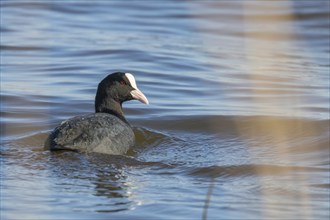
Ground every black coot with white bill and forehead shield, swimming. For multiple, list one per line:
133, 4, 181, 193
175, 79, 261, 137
45, 72, 149, 155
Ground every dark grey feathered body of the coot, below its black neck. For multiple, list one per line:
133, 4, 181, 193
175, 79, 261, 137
45, 113, 135, 154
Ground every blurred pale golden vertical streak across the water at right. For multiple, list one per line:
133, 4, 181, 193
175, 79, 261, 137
237, 1, 313, 219
